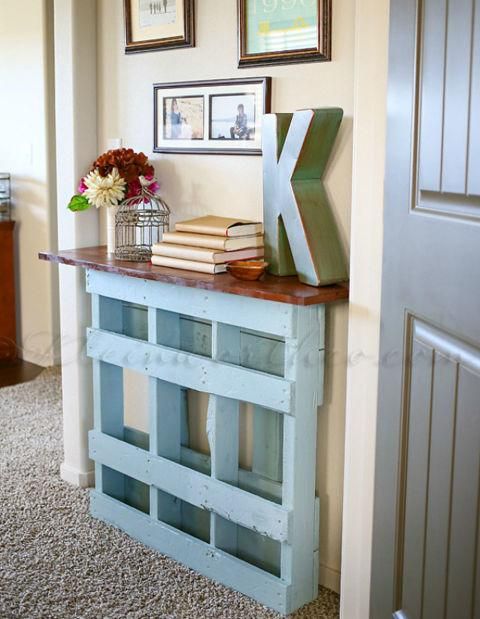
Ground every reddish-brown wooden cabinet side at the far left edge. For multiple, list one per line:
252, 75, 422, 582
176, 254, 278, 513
0, 221, 17, 360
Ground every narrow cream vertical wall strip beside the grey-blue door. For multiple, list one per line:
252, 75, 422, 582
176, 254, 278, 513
341, 0, 390, 619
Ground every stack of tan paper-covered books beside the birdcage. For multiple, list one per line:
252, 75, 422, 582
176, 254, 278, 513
152, 215, 263, 273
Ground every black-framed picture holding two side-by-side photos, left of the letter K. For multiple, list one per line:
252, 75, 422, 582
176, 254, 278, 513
153, 77, 271, 155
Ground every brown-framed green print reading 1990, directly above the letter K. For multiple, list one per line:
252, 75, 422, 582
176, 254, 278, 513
237, 0, 332, 67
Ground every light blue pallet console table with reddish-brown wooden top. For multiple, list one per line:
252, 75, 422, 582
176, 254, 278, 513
40, 248, 348, 614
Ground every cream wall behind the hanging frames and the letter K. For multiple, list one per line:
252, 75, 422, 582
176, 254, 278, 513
97, 0, 354, 590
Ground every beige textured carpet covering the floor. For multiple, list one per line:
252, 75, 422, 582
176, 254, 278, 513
0, 370, 338, 619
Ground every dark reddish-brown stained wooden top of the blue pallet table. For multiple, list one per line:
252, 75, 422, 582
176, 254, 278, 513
39, 246, 348, 305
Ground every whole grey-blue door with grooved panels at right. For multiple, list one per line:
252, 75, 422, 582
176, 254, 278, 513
370, 0, 480, 619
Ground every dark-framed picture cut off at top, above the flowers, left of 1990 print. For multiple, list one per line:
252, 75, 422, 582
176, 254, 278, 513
124, 0, 195, 54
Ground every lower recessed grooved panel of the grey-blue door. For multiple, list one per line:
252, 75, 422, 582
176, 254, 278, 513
397, 317, 480, 619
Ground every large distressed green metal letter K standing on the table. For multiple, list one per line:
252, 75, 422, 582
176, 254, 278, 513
262, 108, 348, 286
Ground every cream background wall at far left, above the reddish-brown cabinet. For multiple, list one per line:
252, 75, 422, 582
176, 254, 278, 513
0, 0, 58, 366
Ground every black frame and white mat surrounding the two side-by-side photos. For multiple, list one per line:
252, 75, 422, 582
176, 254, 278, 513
153, 77, 272, 155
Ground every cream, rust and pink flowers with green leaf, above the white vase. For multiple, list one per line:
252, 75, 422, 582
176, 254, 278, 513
68, 148, 159, 211
